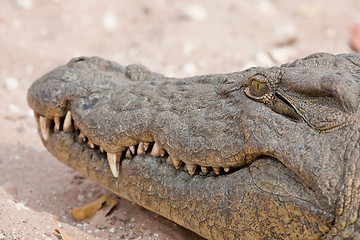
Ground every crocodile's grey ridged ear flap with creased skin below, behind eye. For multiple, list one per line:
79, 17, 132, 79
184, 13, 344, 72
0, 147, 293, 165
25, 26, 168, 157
277, 71, 360, 130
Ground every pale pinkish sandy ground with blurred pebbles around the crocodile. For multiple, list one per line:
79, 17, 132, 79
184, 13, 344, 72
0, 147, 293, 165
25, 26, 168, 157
0, 0, 360, 240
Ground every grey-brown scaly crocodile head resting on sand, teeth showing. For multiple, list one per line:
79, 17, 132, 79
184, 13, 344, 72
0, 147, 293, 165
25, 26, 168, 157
27, 53, 360, 239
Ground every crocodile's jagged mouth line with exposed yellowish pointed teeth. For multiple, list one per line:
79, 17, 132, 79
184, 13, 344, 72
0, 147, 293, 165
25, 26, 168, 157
34, 111, 242, 178
